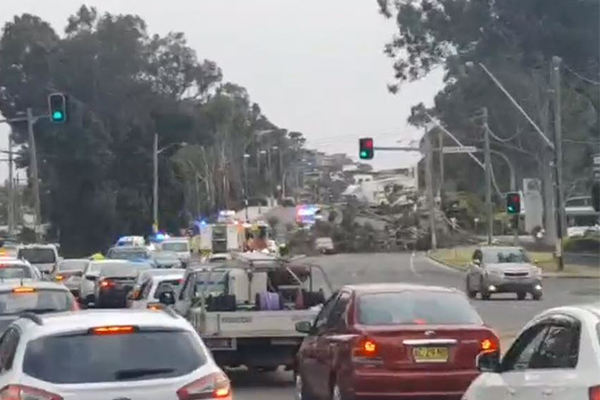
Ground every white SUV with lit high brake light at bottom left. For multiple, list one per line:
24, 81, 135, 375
0, 310, 231, 400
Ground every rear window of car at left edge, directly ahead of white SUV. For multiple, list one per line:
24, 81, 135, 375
0, 288, 74, 315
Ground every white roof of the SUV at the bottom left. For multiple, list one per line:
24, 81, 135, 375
16, 309, 193, 339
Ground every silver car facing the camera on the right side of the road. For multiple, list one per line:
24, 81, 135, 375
466, 246, 543, 300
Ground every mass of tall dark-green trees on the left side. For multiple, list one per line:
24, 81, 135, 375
0, 6, 302, 254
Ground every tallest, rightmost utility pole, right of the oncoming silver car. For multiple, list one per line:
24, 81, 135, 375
551, 56, 566, 271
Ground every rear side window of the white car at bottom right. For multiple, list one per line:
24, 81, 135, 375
529, 324, 580, 369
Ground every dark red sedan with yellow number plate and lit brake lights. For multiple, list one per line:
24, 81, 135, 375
295, 284, 500, 400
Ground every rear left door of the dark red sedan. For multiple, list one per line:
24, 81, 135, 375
315, 291, 351, 399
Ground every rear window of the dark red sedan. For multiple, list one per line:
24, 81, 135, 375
358, 291, 482, 325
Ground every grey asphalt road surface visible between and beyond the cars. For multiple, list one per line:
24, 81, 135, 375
231, 253, 600, 400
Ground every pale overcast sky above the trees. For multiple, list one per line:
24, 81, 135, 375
0, 0, 442, 180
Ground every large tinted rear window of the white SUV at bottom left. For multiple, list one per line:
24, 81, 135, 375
23, 331, 207, 382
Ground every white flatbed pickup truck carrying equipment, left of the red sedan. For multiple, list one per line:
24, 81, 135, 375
159, 253, 332, 371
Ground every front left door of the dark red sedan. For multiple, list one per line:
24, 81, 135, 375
297, 293, 338, 396
